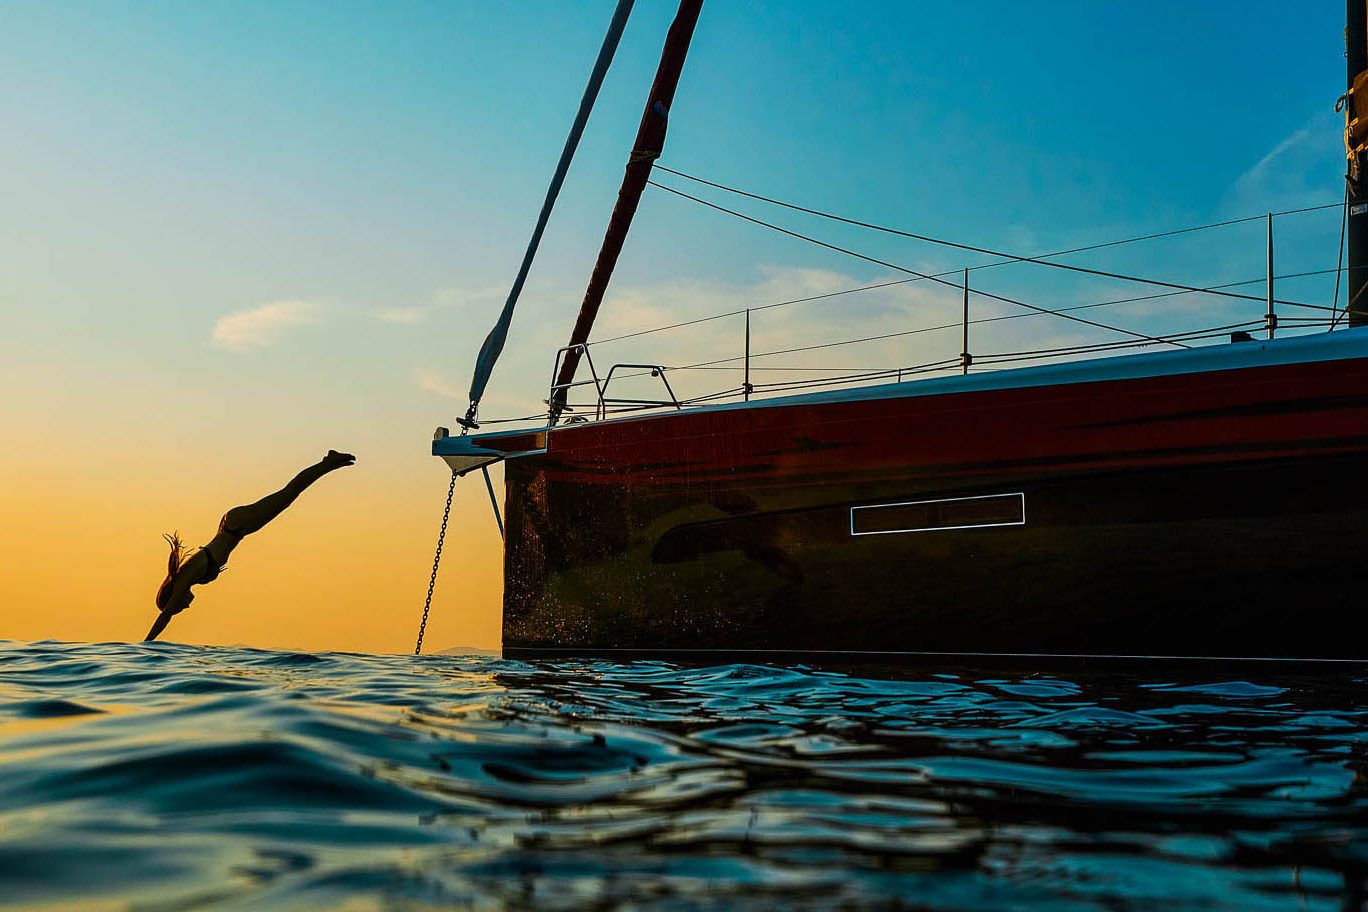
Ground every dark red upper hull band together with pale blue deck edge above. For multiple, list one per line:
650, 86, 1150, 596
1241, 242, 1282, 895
454, 331, 1368, 485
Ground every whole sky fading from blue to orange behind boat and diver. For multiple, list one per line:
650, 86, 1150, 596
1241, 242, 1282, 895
0, 0, 1345, 652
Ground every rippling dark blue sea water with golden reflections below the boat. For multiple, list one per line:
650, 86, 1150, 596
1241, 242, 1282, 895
0, 643, 1368, 912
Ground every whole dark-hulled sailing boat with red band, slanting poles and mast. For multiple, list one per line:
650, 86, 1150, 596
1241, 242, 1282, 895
432, 0, 1368, 659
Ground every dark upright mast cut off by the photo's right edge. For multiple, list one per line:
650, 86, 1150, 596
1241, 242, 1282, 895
1345, 0, 1368, 327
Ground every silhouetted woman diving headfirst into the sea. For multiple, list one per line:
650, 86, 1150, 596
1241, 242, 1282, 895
146, 450, 356, 640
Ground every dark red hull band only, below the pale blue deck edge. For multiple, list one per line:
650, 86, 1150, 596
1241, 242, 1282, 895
547, 352, 1368, 484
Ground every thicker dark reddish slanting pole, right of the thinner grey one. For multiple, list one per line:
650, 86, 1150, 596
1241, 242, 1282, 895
550, 0, 703, 424
